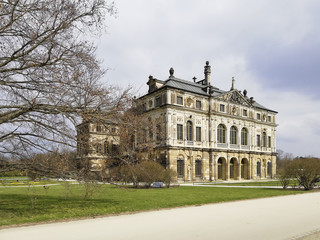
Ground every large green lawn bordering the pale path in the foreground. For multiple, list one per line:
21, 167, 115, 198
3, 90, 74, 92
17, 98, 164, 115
0, 184, 303, 226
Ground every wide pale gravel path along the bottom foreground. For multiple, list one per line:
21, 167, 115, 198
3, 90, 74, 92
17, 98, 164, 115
0, 192, 320, 240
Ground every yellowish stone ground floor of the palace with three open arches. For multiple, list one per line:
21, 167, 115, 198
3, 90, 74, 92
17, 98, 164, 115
144, 149, 276, 181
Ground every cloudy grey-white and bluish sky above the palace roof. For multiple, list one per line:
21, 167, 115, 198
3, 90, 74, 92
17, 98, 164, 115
98, 0, 320, 157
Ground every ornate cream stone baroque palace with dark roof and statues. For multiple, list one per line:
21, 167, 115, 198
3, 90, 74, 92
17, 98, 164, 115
78, 61, 277, 181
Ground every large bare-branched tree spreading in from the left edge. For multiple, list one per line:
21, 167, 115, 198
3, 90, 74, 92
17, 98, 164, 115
0, 0, 123, 163
